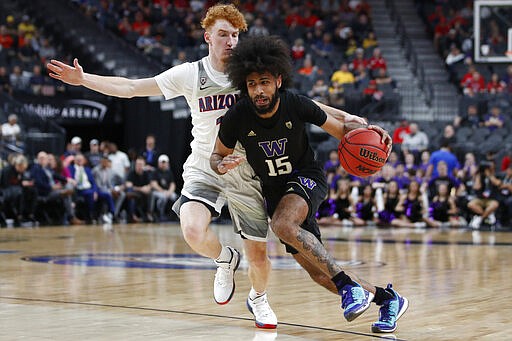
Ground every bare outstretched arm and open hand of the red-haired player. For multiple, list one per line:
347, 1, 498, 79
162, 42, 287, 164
46, 58, 162, 98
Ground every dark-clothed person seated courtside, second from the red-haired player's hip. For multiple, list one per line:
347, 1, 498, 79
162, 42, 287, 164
125, 156, 153, 222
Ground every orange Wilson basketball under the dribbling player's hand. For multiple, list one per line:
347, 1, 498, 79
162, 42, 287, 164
338, 128, 388, 178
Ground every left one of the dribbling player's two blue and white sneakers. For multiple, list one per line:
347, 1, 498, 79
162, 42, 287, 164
341, 282, 373, 322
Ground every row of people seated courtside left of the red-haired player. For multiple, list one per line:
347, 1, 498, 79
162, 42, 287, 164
0, 135, 177, 226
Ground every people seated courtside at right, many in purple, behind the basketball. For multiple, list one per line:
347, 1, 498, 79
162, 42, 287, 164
317, 115, 512, 229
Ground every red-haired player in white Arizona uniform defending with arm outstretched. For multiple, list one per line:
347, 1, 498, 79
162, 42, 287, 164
47, 4, 380, 329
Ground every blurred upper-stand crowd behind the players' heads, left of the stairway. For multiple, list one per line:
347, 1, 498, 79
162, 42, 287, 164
76, 0, 399, 119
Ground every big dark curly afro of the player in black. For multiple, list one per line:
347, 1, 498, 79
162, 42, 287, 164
226, 36, 293, 95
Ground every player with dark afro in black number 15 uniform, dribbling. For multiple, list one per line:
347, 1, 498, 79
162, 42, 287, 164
210, 37, 408, 332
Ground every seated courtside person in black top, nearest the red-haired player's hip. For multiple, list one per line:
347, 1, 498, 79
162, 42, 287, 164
150, 154, 177, 221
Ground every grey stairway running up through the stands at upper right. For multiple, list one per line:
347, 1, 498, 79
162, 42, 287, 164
368, 0, 458, 121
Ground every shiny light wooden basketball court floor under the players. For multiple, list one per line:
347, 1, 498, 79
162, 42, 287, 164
0, 223, 512, 341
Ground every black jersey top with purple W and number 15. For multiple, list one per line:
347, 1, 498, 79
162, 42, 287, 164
219, 91, 327, 196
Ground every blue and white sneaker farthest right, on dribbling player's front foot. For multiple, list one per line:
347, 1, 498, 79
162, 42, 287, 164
372, 284, 409, 333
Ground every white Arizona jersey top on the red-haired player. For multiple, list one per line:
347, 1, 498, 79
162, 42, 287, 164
155, 57, 238, 159
